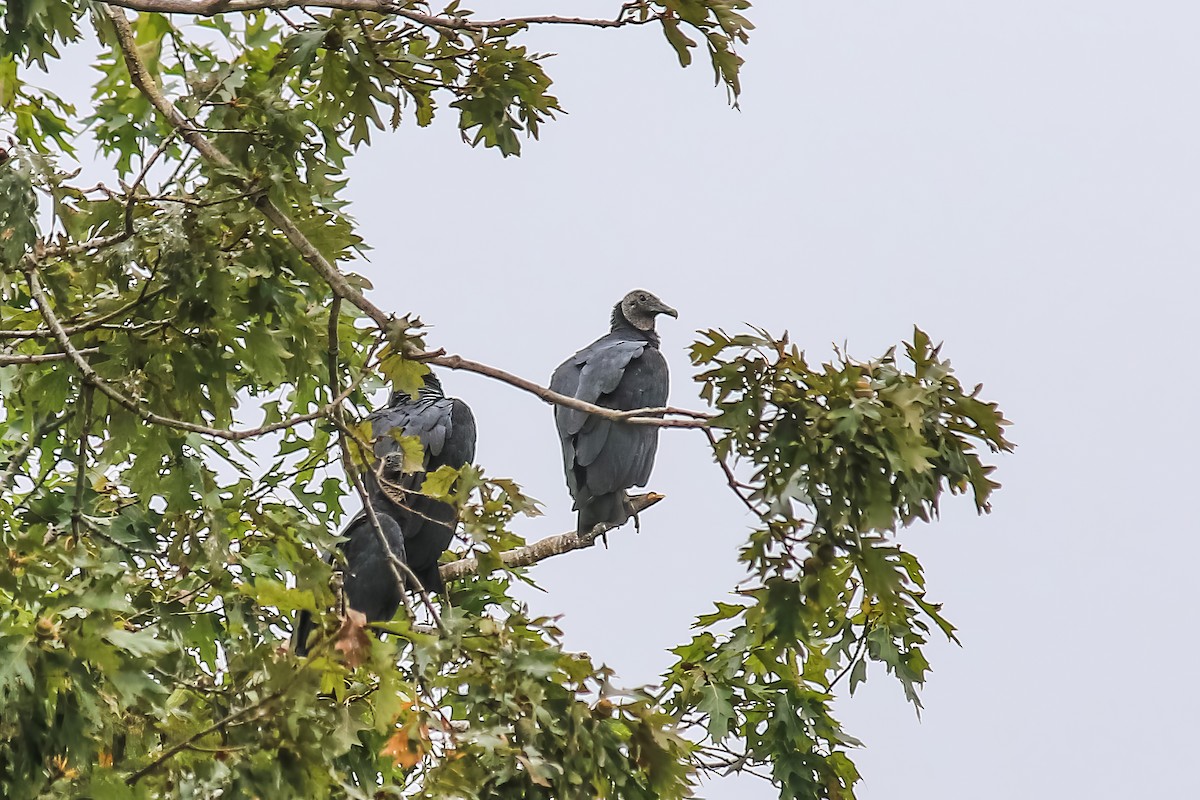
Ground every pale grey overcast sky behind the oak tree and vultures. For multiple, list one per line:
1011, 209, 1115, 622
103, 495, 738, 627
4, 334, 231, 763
340, 0, 1200, 800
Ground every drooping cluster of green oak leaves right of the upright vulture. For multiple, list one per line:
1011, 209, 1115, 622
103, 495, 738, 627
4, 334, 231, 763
665, 330, 1012, 799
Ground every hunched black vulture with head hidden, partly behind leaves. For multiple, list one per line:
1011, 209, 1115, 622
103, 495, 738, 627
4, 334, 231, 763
293, 372, 475, 655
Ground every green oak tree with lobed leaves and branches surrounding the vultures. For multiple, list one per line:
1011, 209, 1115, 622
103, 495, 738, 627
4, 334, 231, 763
0, 0, 1012, 800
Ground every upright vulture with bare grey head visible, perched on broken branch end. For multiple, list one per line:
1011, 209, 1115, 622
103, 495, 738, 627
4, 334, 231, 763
550, 289, 679, 533
